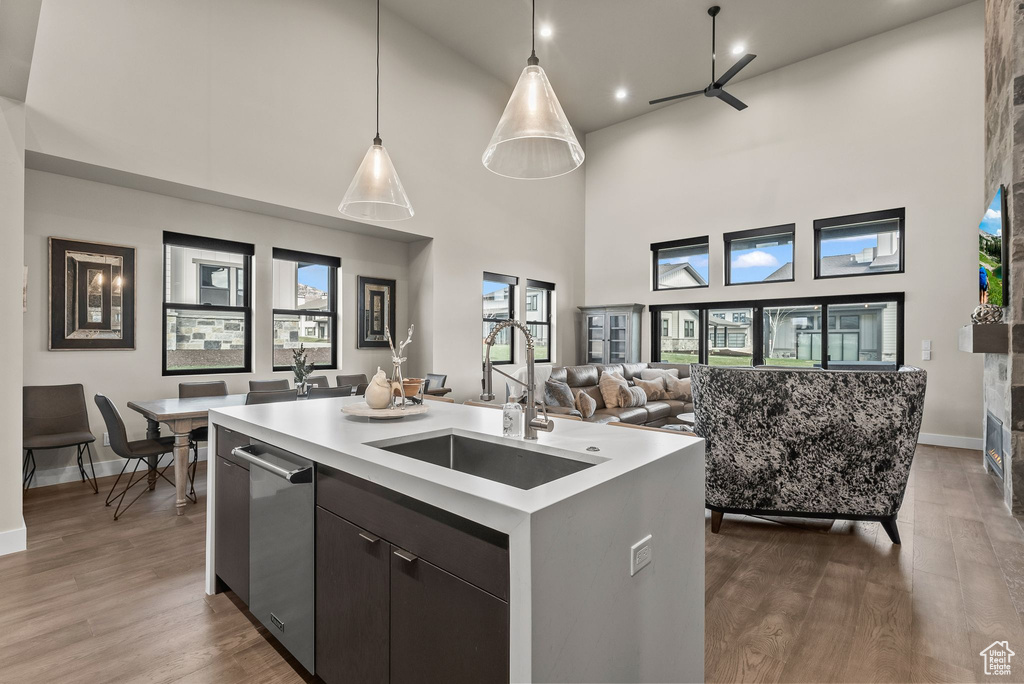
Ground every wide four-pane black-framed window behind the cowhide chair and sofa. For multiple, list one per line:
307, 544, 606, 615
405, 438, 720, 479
651, 293, 904, 370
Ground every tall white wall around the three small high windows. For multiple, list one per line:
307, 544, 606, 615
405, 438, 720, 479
586, 2, 986, 438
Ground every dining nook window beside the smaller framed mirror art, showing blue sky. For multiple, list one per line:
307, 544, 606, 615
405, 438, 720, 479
273, 247, 341, 371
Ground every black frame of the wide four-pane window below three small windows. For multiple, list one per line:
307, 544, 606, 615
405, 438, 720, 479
650, 292, 906, 370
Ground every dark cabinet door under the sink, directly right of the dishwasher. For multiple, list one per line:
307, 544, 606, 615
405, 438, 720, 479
316, 508, 391, 684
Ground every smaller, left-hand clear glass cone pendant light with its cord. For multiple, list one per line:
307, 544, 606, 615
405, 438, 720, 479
338, 0, 415, 221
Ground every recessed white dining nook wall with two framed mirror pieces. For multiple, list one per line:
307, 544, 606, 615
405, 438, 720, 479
24, 171, 410, 471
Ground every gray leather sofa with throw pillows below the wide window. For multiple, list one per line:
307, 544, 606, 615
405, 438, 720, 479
538, 364, 693, 427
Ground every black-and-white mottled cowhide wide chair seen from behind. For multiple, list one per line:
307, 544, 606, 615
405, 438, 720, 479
690, 365, 927, 544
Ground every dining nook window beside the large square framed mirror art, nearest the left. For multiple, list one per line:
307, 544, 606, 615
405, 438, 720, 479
163, 231, 254, 375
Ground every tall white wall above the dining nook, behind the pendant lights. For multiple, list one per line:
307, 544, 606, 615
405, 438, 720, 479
27, 0, 584, 398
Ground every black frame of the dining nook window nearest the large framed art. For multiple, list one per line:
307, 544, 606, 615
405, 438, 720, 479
161, 230, 256, 376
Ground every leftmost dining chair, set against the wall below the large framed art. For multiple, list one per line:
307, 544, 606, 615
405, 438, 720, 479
22, 385, 99, 493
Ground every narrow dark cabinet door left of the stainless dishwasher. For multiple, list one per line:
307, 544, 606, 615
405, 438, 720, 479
214, 456, 249, 605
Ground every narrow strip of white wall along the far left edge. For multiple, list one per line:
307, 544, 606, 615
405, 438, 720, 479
0, 97, 26, 555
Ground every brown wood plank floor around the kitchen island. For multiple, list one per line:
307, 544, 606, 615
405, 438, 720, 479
8, 446, 1024, 684
